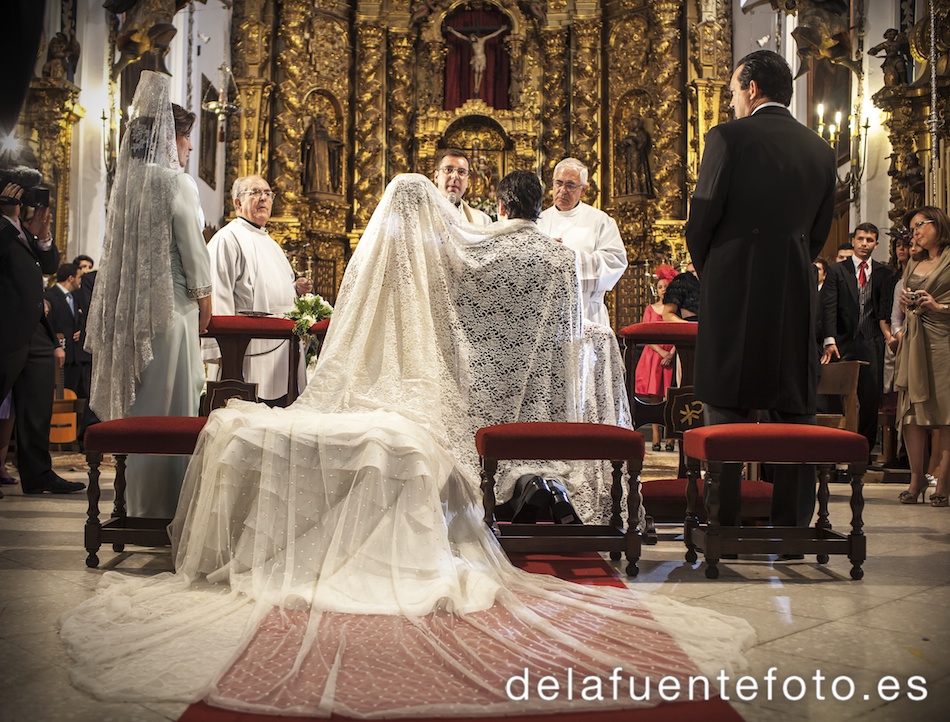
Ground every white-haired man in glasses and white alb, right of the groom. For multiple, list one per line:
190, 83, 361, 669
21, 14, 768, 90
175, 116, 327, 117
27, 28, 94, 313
538, 158, 627, 326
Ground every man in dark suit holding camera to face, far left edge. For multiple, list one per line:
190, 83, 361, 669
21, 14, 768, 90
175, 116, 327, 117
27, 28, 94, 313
0, 167, 86, 494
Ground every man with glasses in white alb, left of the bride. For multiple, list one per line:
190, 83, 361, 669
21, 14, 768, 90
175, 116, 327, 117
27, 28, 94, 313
203, 175, 313, 405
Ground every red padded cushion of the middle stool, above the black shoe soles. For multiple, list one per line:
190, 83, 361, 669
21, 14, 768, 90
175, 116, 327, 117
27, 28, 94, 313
475, 421, 643, 461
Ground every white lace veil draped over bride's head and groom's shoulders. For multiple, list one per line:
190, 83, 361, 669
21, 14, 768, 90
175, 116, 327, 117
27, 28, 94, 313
295, 175, 583, 480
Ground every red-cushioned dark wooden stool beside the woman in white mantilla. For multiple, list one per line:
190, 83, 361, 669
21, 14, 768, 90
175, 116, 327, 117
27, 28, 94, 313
83, 416, 208, 567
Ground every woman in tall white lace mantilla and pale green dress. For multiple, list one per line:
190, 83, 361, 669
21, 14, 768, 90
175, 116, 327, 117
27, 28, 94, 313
86, 71, 211, 518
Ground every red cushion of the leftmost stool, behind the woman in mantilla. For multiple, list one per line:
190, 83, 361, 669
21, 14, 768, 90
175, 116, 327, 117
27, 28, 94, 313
83, 416, 208, 455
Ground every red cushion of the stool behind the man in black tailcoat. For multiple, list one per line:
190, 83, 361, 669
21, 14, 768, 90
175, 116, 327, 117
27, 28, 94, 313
683, 424, 868, 464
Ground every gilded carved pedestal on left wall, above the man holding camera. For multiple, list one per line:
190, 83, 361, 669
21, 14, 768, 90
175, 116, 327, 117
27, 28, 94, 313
20, 78, 86, 253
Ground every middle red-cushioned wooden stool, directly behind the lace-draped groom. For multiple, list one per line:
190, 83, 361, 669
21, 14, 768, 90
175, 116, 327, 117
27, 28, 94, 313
475, 422, 643, 576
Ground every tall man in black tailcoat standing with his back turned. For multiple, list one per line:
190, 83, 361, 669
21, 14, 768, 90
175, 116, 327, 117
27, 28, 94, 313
686, 50, 836, 526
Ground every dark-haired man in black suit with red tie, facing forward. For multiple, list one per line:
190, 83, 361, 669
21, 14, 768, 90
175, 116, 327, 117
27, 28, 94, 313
821, 223, 894, 449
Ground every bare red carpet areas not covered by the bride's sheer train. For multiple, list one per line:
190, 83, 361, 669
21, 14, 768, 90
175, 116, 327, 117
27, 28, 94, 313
179, 552, 742, 722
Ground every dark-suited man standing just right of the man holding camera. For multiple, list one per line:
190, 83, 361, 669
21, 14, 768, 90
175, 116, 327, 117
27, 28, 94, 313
44, 263, 91, 399
